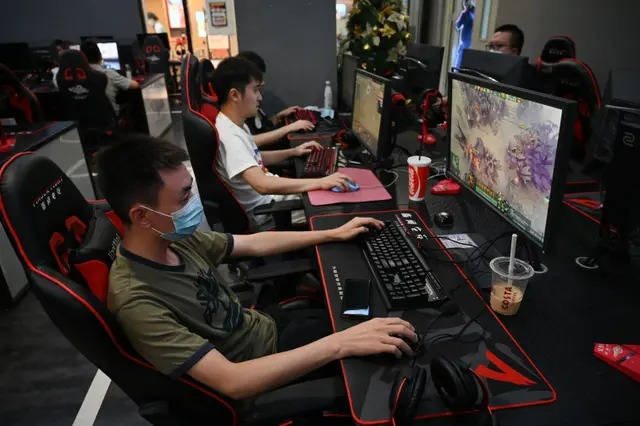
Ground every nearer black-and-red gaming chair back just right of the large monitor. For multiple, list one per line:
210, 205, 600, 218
551, 58, 601, 159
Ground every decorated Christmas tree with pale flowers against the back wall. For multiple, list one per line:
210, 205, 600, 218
341, 0, 411, 76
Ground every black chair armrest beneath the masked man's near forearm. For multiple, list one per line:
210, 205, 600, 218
243, 377, 349, 422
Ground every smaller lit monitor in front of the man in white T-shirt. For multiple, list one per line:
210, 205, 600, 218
352, 69, 392, 159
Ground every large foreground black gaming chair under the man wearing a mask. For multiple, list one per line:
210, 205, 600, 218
0, 153, 346, 426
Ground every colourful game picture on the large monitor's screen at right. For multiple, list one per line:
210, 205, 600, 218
449, 79, 562, 243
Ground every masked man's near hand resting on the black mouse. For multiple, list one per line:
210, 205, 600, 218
325, 318, 418, 359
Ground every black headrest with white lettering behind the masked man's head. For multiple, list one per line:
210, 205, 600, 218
0, 153, 93, 269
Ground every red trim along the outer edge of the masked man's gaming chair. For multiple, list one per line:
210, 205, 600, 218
0, 152, 238, 426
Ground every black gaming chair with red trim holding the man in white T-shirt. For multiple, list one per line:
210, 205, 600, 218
181, 54, 302, 234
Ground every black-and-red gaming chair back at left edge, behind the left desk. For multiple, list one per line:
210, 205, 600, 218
0, 64, 42, 125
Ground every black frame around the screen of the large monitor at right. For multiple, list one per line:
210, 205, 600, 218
447, 72, 577, 252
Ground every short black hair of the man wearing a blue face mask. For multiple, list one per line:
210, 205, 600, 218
97, 134, 189, 225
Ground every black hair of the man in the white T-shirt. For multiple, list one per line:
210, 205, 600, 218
211, 57, 262, 105
